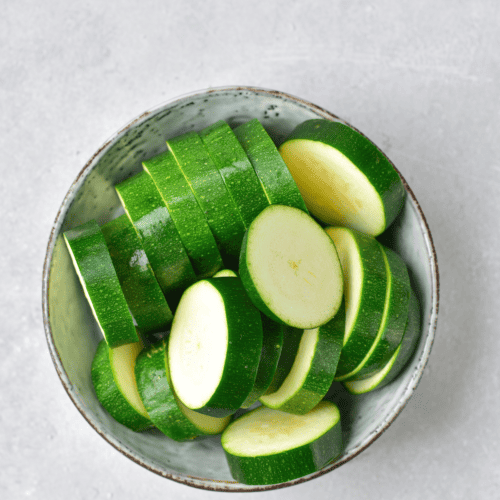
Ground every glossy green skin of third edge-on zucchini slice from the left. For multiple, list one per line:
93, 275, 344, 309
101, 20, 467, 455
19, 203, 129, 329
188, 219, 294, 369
115, 171, 196, 307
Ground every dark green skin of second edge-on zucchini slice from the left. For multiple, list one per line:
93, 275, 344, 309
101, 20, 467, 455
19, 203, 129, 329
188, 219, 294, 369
101, 215, 173, 335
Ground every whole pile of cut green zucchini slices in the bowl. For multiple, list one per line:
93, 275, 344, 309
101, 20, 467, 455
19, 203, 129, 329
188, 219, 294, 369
64, 119, 420, 484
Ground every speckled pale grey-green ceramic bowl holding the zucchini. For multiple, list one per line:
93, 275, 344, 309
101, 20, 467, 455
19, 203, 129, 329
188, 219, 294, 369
43, 87, 439, 492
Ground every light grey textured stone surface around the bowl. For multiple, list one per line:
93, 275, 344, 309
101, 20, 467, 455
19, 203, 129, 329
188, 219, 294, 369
0, 0, 500, 500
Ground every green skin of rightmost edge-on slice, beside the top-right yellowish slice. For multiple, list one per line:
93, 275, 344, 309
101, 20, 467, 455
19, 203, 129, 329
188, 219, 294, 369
234, 118, 309, 214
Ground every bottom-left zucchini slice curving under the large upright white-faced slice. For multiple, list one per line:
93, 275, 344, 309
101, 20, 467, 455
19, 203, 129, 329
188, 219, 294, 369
135, 340, 231, 441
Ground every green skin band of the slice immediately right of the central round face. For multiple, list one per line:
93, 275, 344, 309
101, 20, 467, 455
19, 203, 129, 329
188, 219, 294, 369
326, 228, 387, 380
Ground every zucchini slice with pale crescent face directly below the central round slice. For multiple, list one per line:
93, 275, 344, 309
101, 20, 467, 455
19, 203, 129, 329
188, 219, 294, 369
260, 303, 345, 415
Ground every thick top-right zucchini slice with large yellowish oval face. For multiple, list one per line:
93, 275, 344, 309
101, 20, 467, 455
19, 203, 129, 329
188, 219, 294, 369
279, 119, 405, 236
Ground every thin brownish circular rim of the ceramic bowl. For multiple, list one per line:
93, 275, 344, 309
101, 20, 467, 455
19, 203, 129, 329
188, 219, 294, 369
42, 85, 439, 493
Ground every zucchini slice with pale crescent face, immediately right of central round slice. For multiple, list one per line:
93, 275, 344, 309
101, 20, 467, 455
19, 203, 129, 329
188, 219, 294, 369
325, 227, 387, 380
